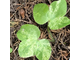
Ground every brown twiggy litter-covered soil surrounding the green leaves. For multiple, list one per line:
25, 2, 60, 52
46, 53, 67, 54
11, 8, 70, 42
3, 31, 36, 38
10, 0, 70, 60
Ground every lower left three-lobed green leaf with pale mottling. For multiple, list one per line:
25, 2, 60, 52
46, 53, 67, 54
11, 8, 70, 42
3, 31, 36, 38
17, 24, 51, 60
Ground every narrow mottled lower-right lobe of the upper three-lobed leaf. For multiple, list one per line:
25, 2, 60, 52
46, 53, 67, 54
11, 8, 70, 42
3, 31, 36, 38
48, 17, 70, 30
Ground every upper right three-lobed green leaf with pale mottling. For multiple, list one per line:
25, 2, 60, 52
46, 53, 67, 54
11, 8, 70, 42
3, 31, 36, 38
33, 0, 70, 30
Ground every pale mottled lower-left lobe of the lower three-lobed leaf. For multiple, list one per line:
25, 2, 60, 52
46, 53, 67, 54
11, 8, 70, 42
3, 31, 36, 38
18, 39, 36, 58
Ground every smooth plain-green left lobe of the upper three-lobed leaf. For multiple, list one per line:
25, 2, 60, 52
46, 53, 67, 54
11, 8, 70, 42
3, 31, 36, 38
33, 3, 49, 24
